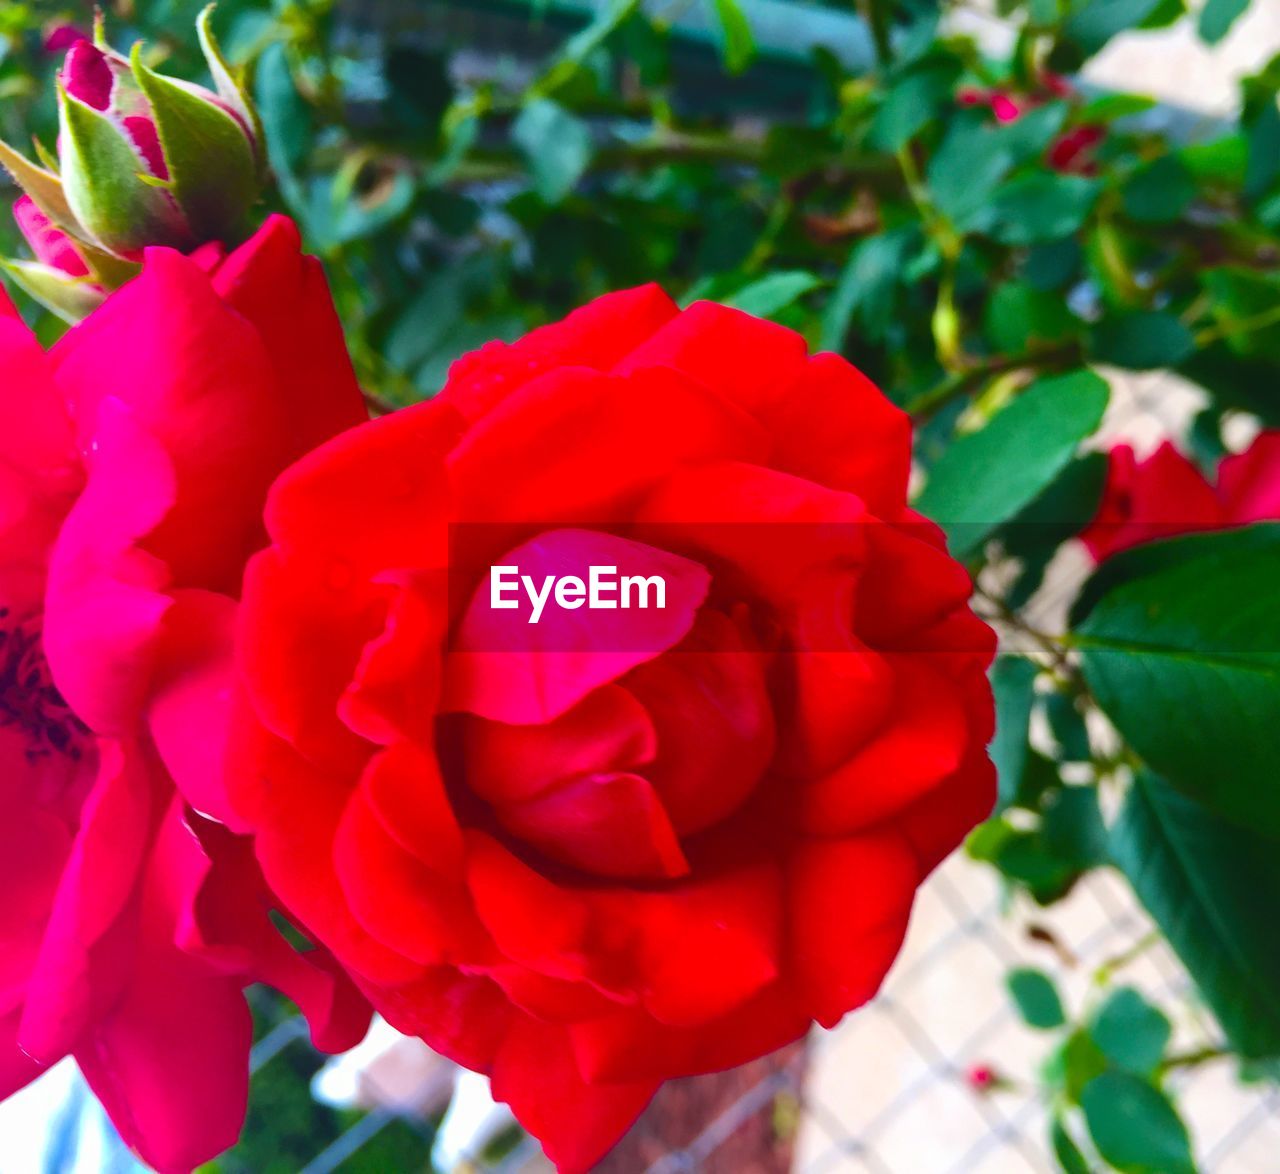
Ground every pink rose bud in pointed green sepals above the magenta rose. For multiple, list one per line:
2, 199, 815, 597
0, 9, 262, 320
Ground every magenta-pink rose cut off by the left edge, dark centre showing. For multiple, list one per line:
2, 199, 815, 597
0, 219, 369, 1170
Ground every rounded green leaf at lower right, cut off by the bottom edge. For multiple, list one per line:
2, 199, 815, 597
1080, 1072, 1196, 1174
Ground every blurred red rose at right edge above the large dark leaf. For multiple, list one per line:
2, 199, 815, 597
1080, 431, 1280, 562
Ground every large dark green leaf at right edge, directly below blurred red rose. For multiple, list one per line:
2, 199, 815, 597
1075, 524, 1280, 836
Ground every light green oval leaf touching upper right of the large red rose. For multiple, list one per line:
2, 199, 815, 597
916, 371, 1107, 557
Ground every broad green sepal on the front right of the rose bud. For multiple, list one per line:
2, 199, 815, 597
131, 41, 259, 243
